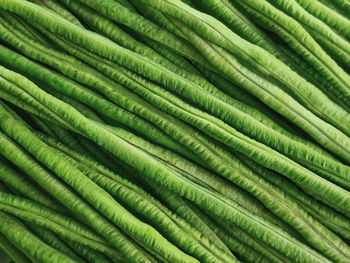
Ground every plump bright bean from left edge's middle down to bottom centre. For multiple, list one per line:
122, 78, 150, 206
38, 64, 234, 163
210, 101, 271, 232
1, 90, 196, 262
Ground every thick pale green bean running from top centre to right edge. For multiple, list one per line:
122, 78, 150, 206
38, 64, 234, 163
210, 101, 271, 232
82, 1, 350, 141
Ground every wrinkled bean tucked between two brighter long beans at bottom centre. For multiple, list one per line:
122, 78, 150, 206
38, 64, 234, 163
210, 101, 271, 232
42, 134, 234, 262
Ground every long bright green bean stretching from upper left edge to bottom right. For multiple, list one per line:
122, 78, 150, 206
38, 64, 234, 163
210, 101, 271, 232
0, 62, 334, 262
